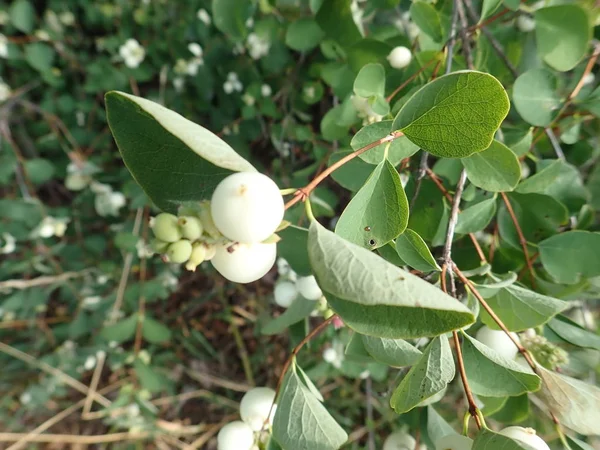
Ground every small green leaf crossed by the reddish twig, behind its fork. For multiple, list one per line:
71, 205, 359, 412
350, 120, 419, 166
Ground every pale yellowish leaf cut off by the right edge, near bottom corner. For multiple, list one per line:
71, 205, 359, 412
538, 366, 600, 436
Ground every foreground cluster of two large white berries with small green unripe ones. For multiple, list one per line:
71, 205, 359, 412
151, 172, 284, 283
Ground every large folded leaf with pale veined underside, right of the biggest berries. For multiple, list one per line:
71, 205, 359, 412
308, 221, 475, 339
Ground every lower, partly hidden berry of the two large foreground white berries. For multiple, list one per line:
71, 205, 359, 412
210, 244, 277, 283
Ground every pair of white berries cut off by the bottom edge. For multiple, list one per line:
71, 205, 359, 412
217, 387, 277, 450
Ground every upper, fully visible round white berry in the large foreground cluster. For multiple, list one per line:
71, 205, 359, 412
211, 172, 284, 244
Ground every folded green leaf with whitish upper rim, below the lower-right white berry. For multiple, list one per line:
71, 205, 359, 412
462, 333, 541, 397
